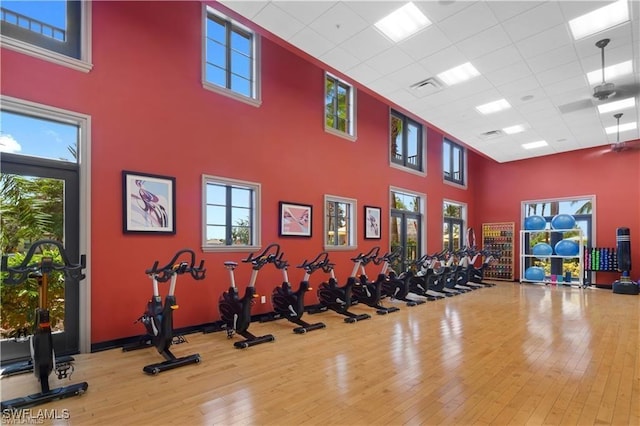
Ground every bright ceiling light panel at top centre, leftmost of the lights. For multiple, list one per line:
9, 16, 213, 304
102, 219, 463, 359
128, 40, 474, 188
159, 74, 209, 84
309, 2, 369, 43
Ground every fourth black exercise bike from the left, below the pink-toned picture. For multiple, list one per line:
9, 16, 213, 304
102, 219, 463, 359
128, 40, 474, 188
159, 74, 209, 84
271, 252, 327, 334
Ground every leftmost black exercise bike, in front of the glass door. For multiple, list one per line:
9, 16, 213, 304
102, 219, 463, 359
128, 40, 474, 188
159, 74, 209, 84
1, 240, 89, 412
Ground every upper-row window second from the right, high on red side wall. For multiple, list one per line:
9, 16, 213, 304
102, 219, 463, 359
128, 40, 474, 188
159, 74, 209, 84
390, 111, 424, 171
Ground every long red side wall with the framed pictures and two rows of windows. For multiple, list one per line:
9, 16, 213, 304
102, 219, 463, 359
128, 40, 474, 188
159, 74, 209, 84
1, 2, 480, 343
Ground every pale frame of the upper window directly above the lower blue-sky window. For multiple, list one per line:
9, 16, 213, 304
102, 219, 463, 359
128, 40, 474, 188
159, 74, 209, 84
201, 4, 262, 107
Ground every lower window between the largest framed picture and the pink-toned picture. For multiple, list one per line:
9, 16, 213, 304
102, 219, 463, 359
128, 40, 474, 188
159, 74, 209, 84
203, 175, 260, 251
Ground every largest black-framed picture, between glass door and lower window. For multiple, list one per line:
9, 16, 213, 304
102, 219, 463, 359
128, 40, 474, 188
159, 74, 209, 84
122, 170, 176, 234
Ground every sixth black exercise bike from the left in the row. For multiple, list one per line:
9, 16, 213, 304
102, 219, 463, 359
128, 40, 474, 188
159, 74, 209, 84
351, 247, 400, 315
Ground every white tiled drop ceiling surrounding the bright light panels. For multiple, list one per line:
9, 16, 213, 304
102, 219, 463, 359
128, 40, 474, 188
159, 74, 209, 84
220, 0, 640, 162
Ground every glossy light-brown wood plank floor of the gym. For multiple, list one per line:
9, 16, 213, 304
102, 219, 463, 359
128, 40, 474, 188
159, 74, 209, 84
0, 282, 640, 425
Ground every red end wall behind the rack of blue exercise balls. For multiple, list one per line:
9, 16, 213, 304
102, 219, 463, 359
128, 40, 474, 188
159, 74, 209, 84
474, 146, 640, 282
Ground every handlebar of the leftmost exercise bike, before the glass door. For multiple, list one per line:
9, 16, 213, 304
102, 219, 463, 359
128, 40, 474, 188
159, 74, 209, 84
0, 240, 87, 285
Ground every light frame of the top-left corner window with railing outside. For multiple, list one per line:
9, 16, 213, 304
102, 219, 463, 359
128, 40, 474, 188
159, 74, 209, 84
0, 0, 93, 72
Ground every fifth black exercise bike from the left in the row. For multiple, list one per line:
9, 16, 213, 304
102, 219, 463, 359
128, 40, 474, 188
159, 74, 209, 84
317, 256, 371, 323
